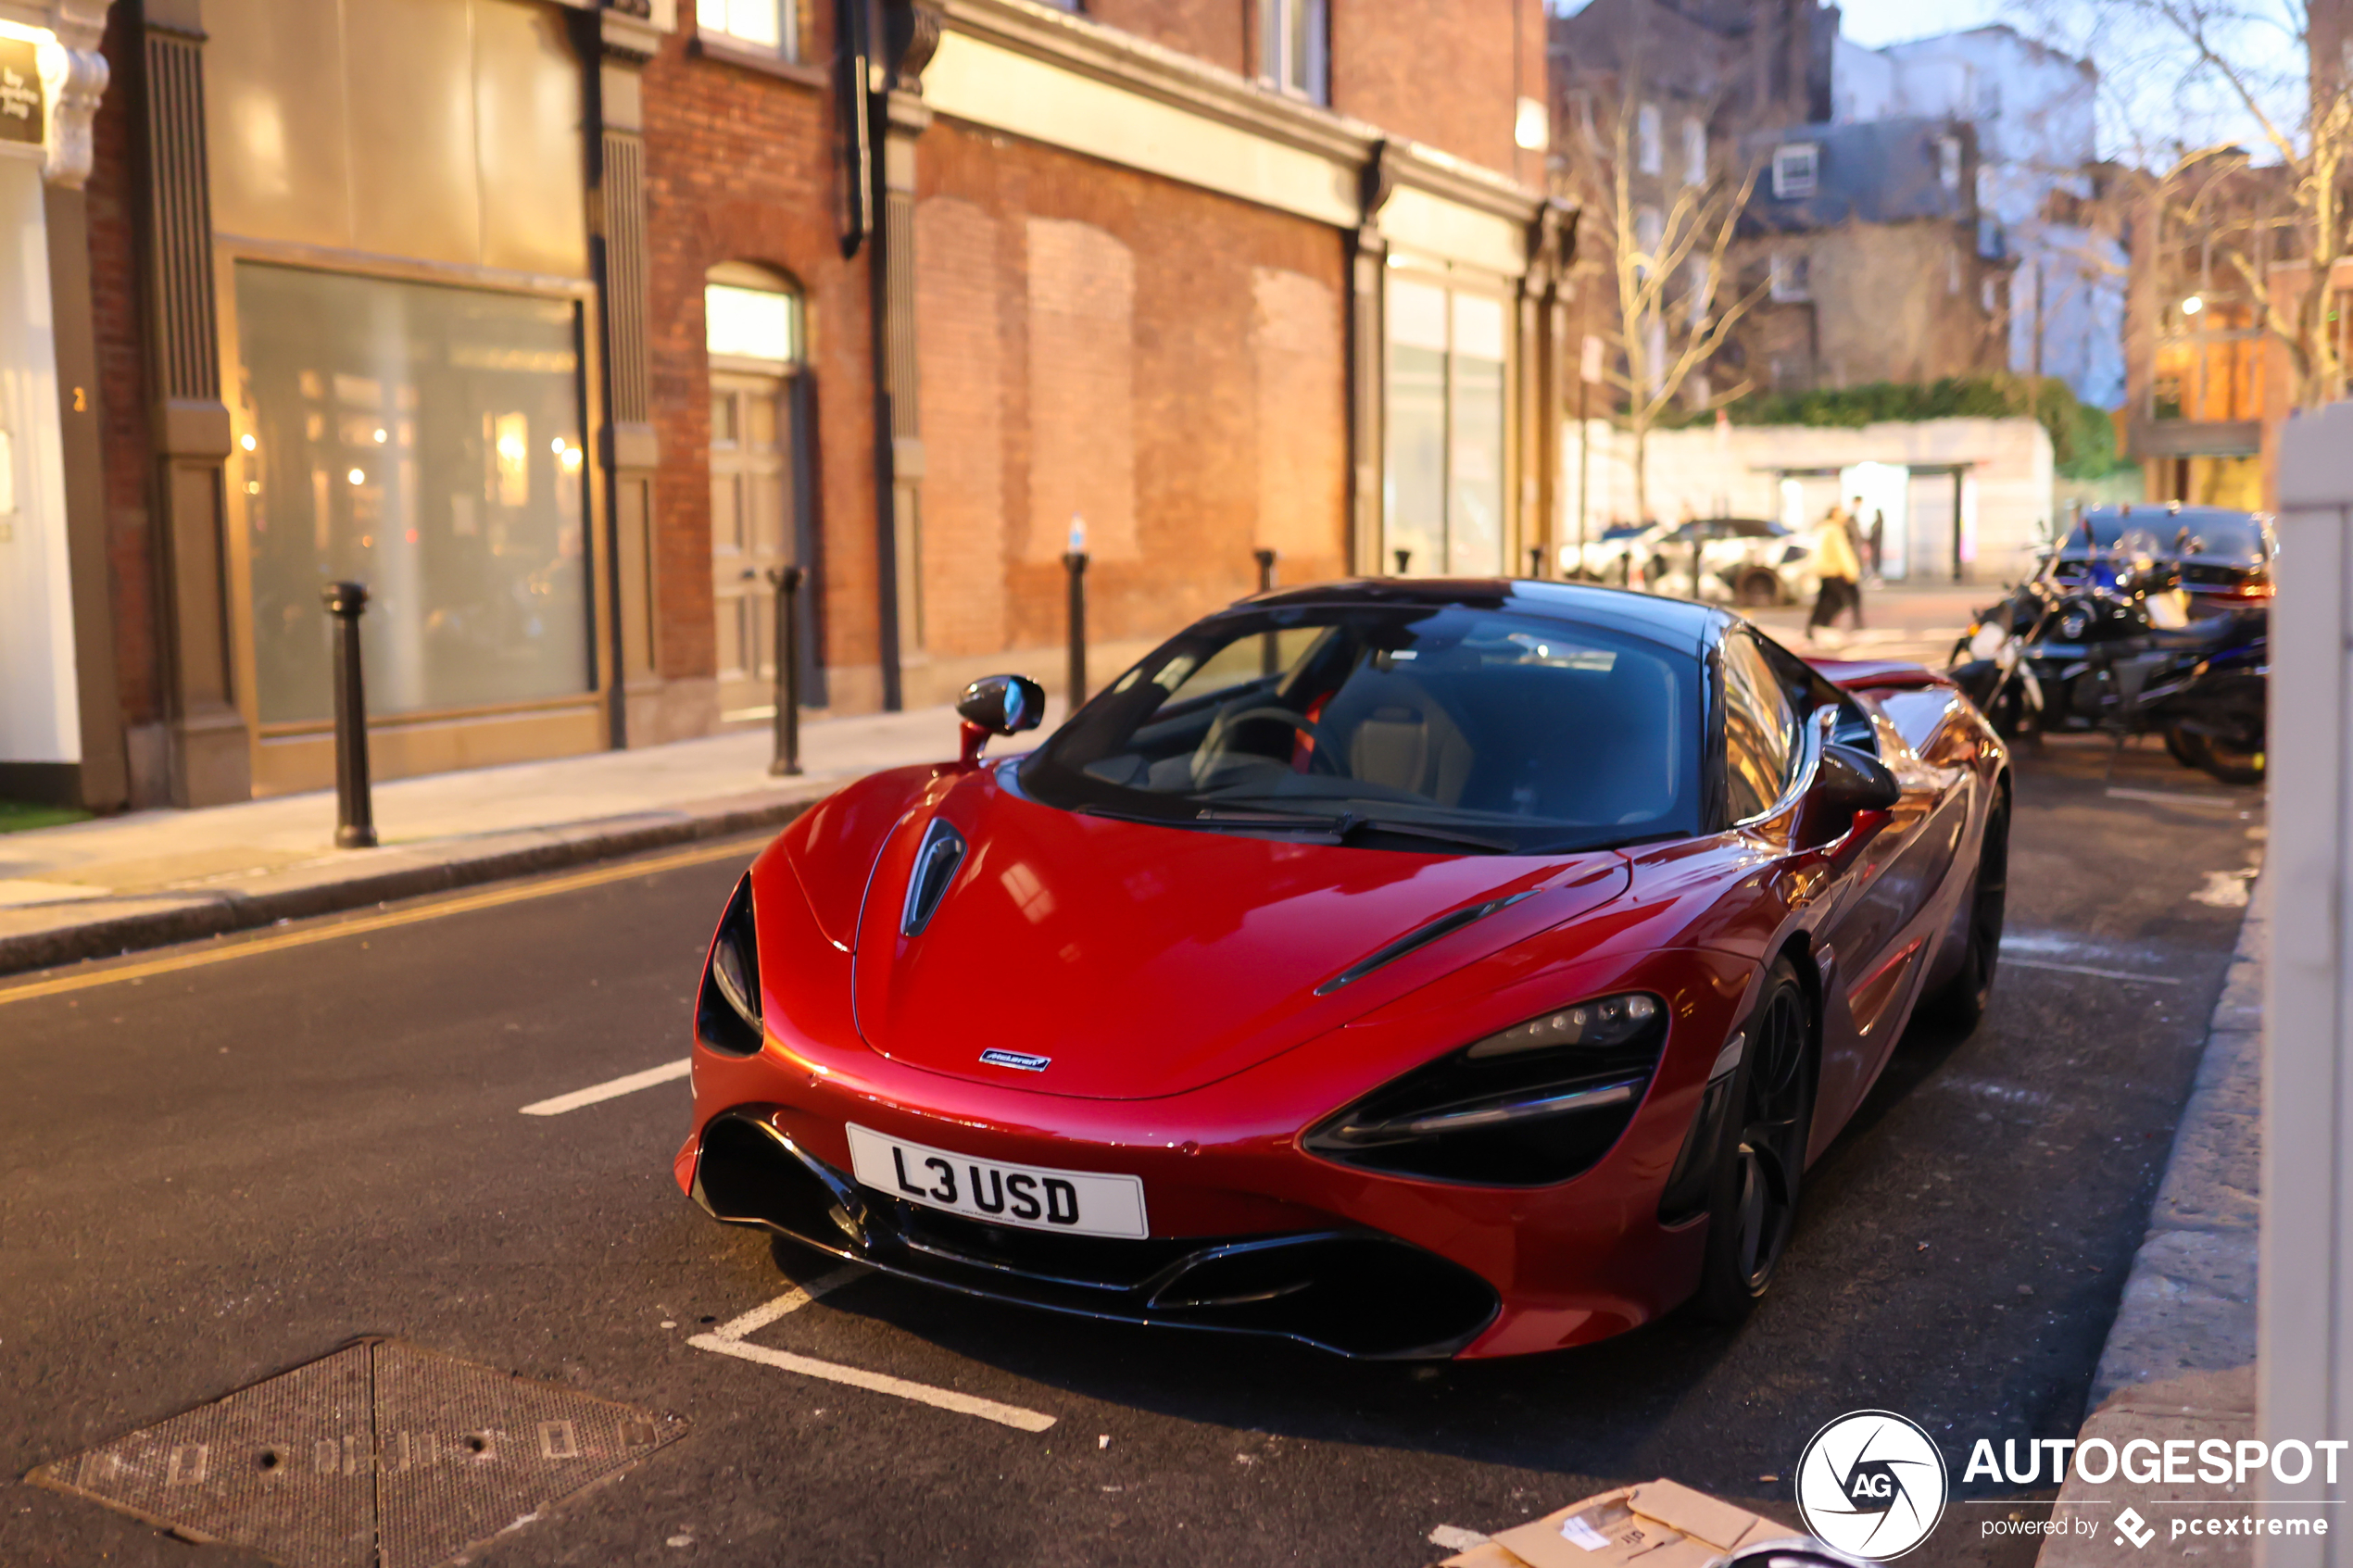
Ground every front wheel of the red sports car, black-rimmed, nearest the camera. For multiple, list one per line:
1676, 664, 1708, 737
1694, 960, 1817, 1323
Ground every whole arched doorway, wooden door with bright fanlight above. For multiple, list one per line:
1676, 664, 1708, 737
703, 261, 824, 724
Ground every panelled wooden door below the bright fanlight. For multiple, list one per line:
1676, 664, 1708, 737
711, 371, 798, 721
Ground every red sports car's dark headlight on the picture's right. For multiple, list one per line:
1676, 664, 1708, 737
1306, 992, 1666, 1187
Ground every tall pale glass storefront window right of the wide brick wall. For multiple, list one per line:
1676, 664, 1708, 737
1381, 275, 1506, 576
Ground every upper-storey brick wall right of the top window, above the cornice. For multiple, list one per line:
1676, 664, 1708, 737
1332, 0, 1546, 186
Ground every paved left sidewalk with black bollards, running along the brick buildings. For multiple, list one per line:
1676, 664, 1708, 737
0, 708, 1002, 975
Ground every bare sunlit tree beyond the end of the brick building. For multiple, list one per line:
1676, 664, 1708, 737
1560, 78, 1769, 517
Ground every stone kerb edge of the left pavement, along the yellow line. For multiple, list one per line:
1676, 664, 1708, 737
0, 778, 845, 975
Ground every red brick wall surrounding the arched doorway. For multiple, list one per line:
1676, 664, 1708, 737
645, 26, 875, 705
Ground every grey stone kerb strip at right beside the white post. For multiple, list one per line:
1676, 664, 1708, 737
2035, 877, 2271, 1568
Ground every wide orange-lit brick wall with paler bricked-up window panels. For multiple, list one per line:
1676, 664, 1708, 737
918, 119, 1346, 674
